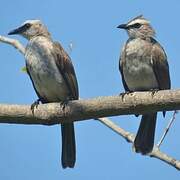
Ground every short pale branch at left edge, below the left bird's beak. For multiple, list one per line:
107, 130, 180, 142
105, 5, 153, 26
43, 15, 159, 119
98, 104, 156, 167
0, 35, 25, 55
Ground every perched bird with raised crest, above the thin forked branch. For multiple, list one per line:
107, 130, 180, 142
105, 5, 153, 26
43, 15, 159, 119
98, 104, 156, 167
118, 15, 171, 154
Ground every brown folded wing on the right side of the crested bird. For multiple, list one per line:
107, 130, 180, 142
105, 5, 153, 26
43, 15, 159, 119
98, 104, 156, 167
151, 39, 171, 90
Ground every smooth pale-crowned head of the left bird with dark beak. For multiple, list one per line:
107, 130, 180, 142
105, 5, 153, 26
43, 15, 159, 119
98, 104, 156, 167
8, 20, 50, 40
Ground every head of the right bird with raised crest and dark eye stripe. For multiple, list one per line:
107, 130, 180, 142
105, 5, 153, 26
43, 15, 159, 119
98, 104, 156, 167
117, 15, 155, 38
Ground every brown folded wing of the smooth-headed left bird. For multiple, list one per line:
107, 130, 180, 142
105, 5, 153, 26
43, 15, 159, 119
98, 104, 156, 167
53, 42, 79, 99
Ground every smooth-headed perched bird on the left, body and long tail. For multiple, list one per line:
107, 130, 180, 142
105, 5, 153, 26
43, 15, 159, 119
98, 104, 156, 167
8, 20, 79, 168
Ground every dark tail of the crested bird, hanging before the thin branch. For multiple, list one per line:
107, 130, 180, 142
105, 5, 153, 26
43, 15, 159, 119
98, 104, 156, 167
134, 113, 157, 154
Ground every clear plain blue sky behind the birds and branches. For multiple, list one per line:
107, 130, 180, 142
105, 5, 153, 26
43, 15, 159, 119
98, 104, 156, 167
0, 0, 180, 180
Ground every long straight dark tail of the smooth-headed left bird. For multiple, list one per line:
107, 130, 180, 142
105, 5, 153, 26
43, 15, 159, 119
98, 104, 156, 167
61, 123, 76, 168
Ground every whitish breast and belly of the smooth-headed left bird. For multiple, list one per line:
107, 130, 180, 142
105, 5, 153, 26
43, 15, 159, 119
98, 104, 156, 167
25, 37, 68, 102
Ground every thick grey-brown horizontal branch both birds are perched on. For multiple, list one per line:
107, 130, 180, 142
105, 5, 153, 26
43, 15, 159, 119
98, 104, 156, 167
0, 90, 180, 125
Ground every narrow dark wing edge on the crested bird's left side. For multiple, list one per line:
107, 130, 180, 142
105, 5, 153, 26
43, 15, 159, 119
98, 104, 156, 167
119, 42, 129, 91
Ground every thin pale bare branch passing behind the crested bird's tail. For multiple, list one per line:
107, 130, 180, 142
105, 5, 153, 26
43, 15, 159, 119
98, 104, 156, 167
97, 118, 180, 170
